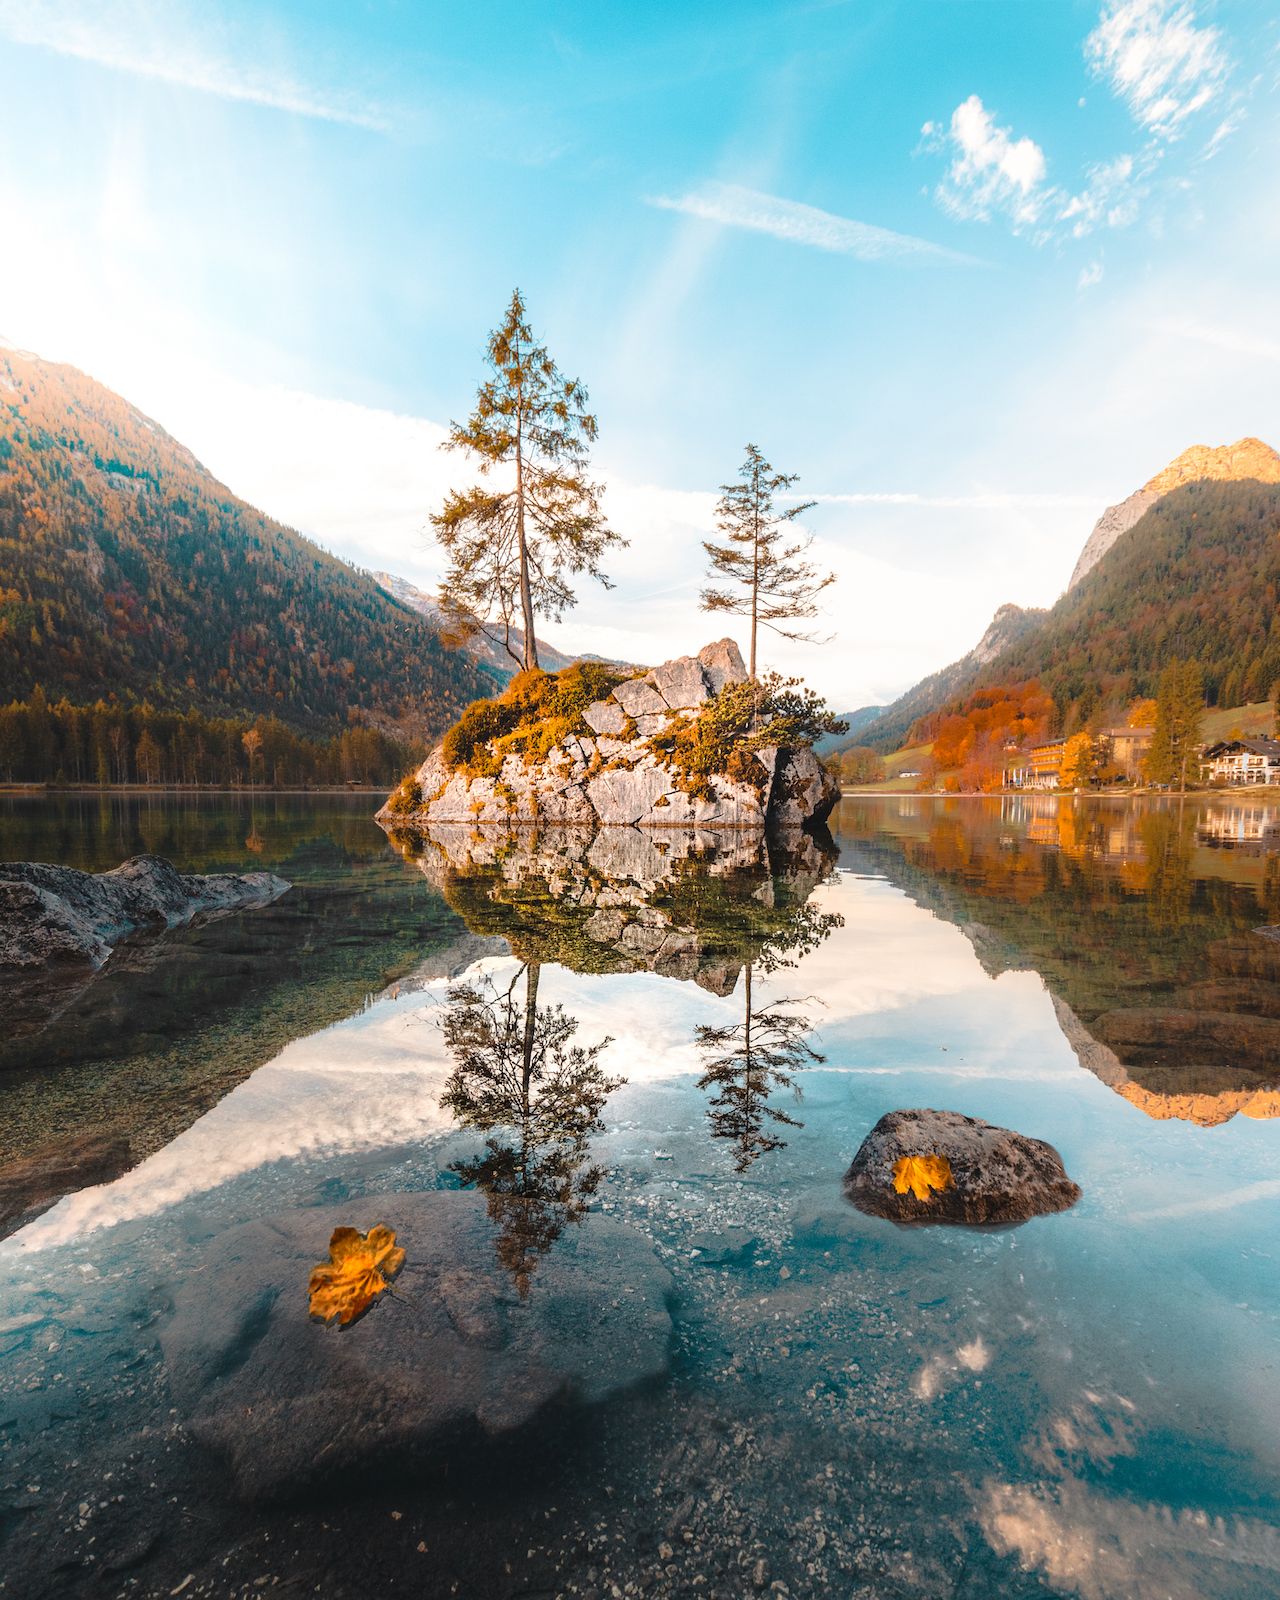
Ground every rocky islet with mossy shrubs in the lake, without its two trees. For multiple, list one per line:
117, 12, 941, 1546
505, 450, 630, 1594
378, 638, 843, 830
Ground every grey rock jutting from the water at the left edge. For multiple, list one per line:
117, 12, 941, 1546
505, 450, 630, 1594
0, 856, 290, 974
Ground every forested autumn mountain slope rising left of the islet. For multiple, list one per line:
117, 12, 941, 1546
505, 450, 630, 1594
0, 344, 494, 736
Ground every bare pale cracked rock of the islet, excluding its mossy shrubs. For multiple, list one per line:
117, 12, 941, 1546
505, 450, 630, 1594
378, 638, 840, 830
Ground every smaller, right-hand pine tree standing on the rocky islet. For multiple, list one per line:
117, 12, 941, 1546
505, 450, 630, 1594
702, 445, 835, 683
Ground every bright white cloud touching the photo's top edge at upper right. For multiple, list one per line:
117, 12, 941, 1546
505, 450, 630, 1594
1085, 0, 1230, 139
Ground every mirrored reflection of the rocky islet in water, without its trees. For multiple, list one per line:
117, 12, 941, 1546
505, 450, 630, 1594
392, 824, 835, 995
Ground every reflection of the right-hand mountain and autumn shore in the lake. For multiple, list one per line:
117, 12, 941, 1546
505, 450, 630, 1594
840, 795, 1280, 1126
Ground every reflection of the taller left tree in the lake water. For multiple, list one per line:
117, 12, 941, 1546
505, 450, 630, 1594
440, 962, 624, 1299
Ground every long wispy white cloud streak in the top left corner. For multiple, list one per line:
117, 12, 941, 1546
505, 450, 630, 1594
0, 0, 390, 133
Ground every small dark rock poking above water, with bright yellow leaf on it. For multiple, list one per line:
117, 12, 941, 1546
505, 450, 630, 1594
845, 1109, 1080, 1222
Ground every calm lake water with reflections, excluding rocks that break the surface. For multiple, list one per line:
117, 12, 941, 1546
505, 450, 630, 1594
0, 797, 1280, 1600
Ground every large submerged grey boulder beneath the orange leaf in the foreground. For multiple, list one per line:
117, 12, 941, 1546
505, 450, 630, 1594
160, 1190, 670, 1499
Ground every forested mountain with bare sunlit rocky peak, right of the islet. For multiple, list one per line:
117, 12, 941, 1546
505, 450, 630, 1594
862, 438, 1280, 749
